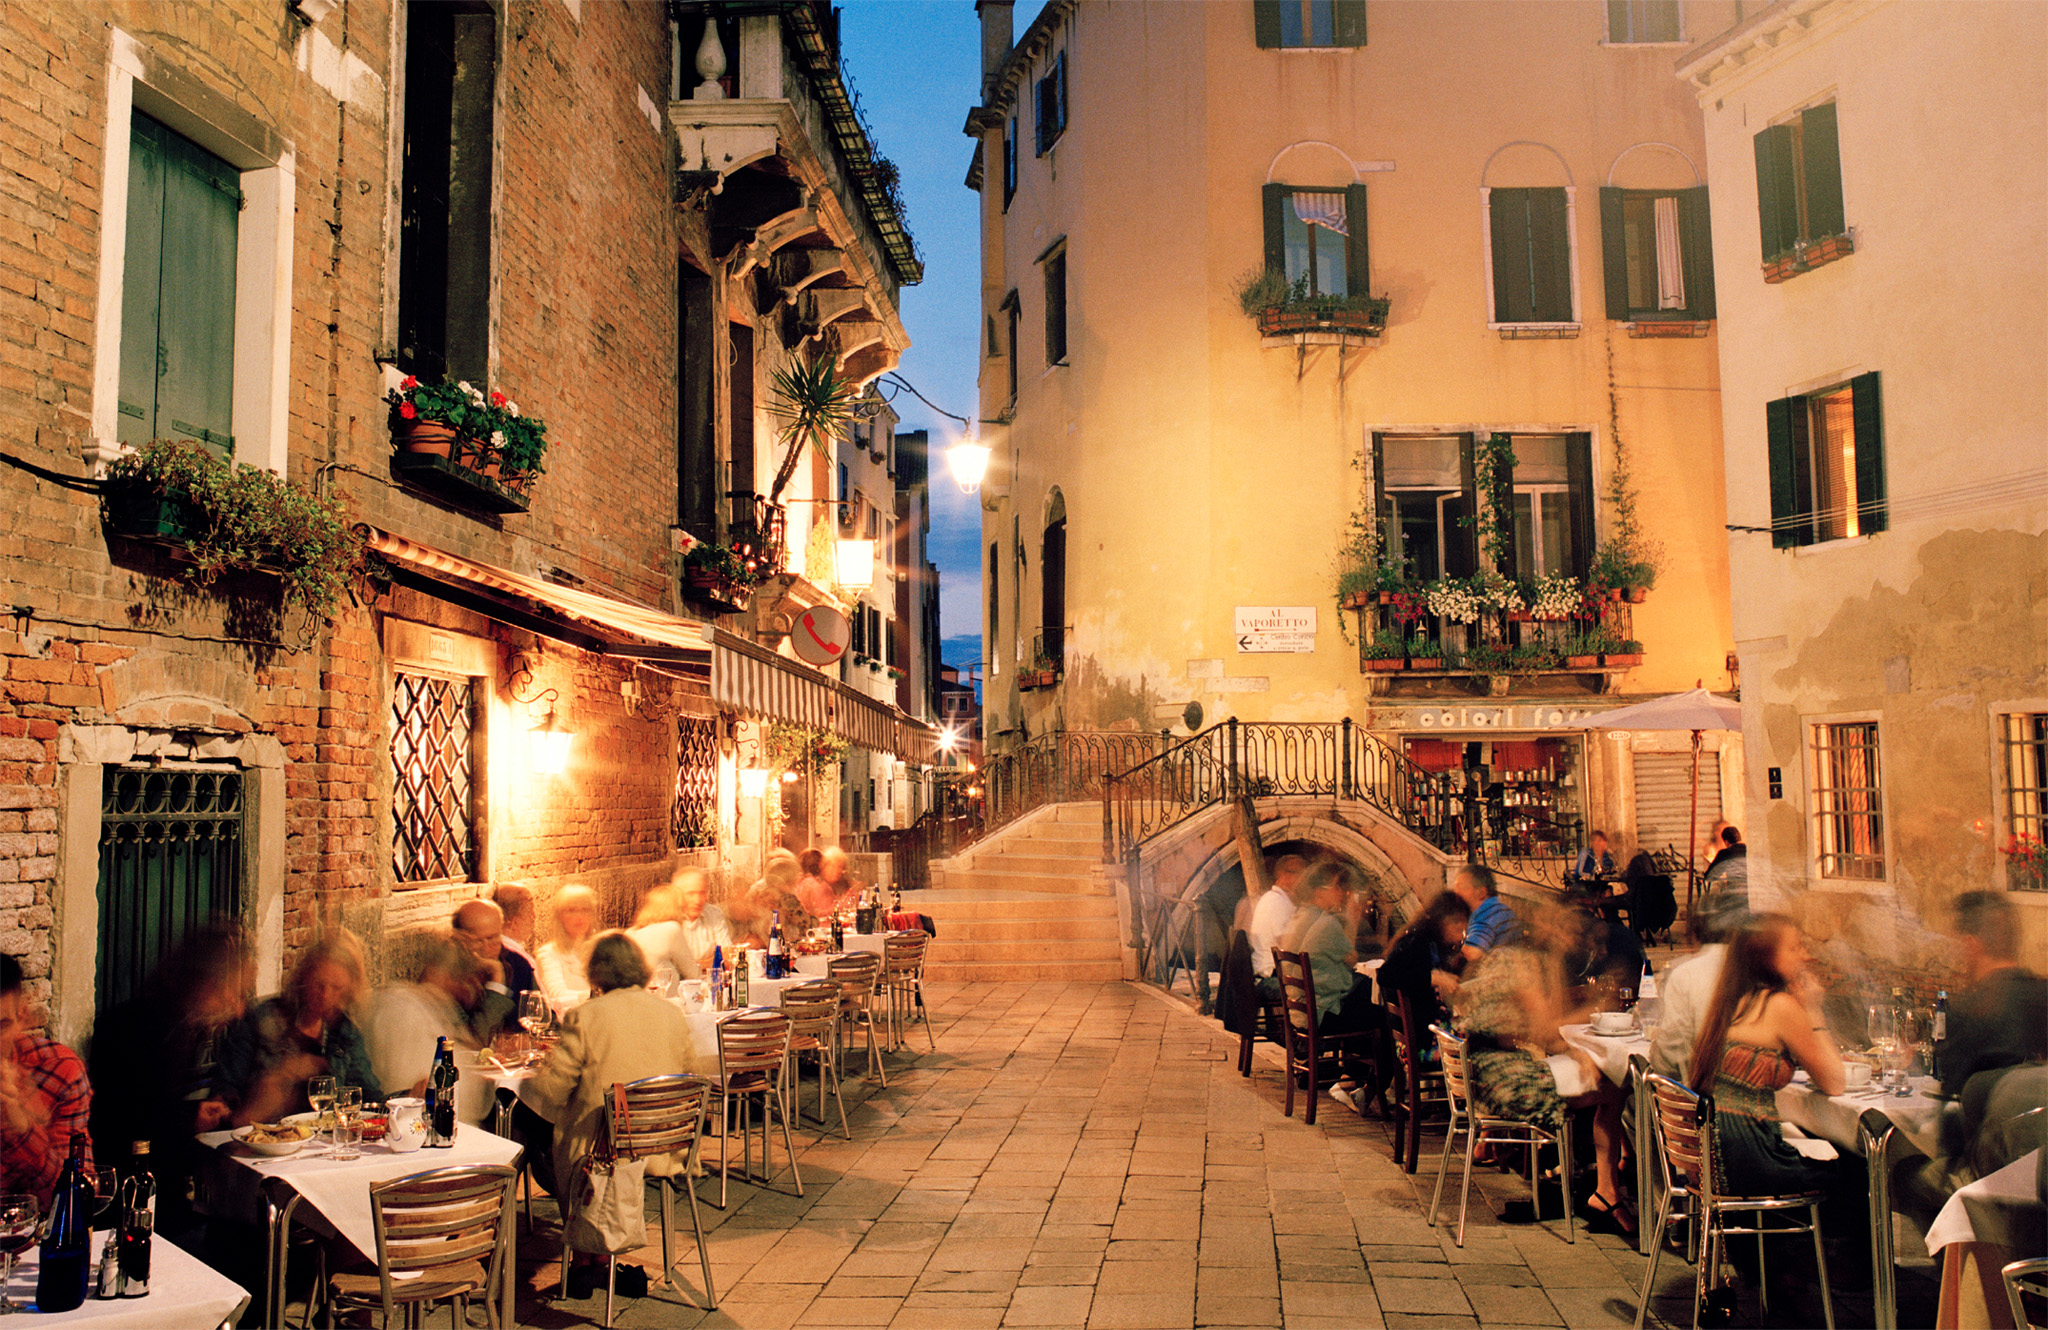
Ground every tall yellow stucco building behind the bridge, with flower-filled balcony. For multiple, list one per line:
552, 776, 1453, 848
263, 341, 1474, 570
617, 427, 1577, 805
969, 0, 1745, 881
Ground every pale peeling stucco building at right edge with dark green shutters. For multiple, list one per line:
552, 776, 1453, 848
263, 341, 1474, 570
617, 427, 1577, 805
1681, 0, 2048, 969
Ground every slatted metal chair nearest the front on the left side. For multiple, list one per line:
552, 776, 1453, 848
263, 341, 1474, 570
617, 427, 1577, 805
326, 1164, 518, 1330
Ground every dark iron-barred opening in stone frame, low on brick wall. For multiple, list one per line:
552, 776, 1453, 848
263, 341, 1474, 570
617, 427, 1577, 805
94, 766, 244, 1012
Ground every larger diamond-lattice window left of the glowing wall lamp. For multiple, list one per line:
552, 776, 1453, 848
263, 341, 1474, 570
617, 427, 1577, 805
391, 670, 477, 881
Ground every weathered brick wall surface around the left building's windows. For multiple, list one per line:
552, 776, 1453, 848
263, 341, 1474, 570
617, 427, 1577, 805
0, 0, 678, 1008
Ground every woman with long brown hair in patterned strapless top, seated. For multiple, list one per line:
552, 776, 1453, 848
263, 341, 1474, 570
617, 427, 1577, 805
1688, 914, 1862, 1197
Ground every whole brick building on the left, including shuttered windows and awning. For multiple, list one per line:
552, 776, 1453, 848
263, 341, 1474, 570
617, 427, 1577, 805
0, 0, 915, 1037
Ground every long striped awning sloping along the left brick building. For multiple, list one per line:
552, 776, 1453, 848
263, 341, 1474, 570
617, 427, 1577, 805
362, 527, 938, 764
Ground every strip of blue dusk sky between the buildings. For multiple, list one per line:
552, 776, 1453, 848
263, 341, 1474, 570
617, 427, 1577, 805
840, 0, 1042, 664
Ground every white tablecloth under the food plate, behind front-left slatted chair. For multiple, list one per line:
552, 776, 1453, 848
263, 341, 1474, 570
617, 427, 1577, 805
196, 1123, 520, 1256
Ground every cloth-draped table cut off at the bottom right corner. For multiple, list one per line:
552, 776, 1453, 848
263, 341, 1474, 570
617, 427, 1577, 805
1927, 1150, 2048, 1330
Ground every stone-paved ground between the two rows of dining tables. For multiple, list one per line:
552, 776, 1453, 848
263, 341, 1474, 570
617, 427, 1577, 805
507, 984, 1690, 1330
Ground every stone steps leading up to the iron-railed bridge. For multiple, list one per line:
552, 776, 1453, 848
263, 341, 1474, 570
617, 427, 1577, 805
903, 803, 1124, 982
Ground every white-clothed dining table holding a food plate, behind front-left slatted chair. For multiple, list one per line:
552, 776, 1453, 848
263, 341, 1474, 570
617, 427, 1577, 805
194, 1123, 520, 1326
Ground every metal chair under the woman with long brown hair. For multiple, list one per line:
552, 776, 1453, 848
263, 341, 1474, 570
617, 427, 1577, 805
1636, 1072, 1835, 1330
